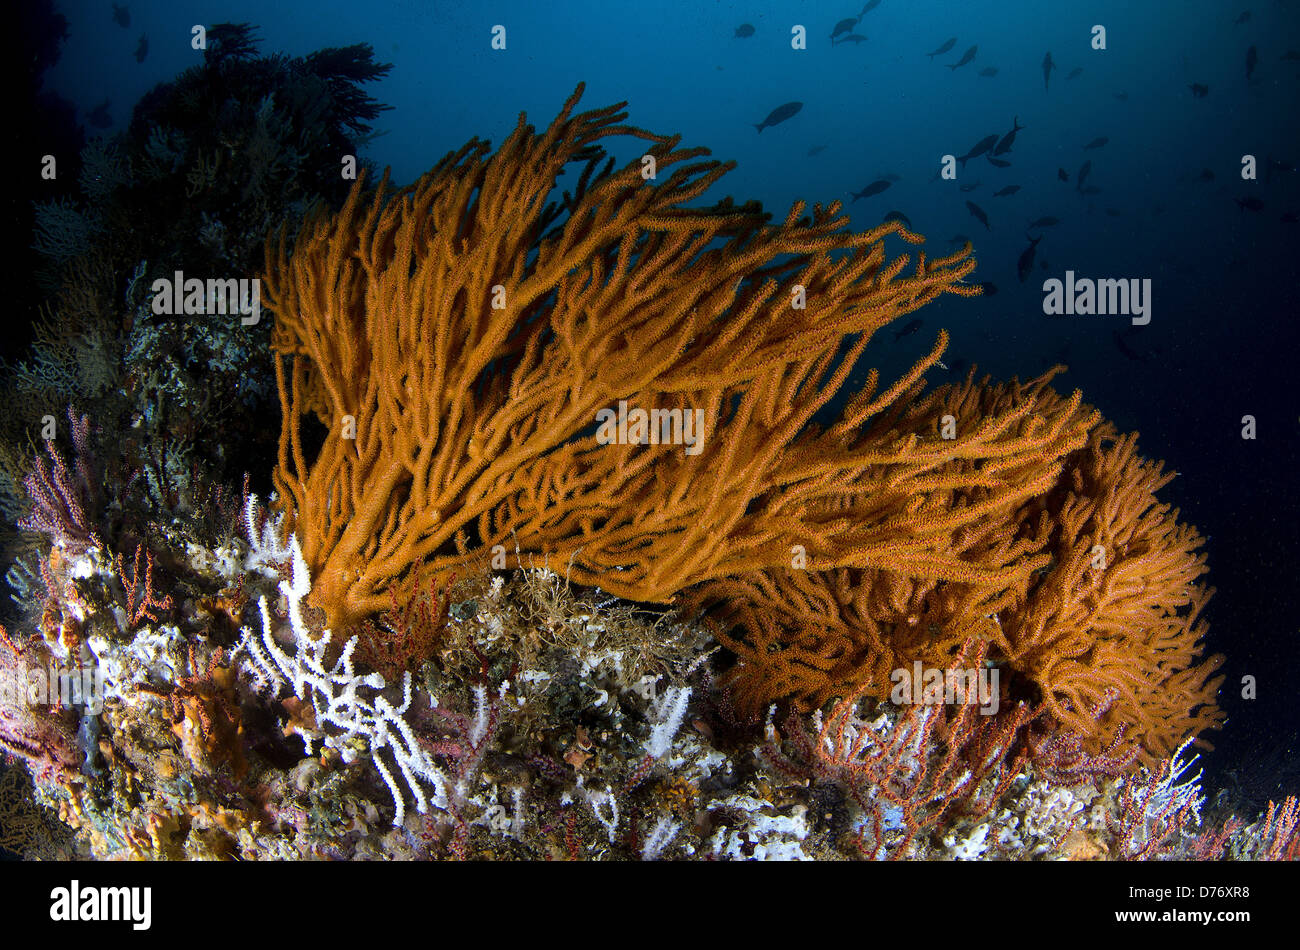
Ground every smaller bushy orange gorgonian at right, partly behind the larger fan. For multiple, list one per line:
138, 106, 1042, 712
692, 374, 1222, 764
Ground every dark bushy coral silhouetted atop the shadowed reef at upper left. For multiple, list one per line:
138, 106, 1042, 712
120, 23, 390, 274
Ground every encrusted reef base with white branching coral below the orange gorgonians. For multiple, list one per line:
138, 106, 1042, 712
0, 512, 1296, 860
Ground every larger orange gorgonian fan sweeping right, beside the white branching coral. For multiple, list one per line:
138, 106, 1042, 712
267, 83, 1060, 628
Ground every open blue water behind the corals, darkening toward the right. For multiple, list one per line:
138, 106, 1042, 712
30, 0, 1300, 800
